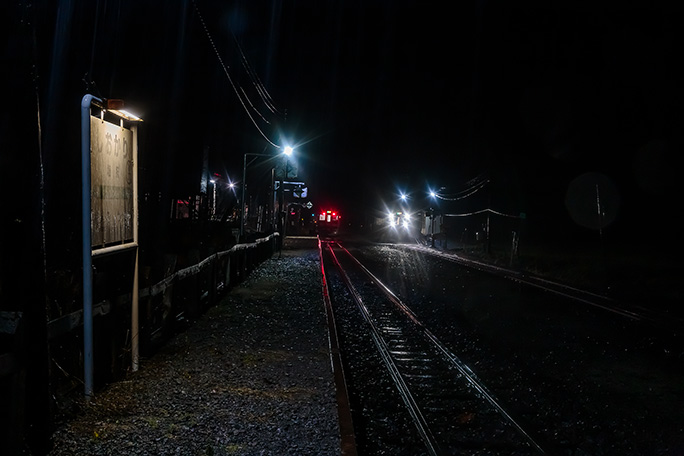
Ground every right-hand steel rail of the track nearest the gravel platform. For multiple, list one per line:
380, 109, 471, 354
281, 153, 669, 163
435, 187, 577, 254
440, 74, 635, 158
329, 242, 546, 454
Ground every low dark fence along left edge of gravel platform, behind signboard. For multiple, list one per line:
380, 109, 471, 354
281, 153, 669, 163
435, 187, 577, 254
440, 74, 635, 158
41, 233, 279, 400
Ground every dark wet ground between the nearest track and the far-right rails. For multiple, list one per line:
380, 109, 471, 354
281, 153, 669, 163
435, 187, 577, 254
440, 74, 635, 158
356, 246, 684, 455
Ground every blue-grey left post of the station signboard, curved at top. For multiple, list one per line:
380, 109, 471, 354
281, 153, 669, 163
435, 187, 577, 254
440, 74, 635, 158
81, 95, 100, 400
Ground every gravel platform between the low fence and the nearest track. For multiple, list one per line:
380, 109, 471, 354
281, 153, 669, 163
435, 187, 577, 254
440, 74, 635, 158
50, 250, 340, 456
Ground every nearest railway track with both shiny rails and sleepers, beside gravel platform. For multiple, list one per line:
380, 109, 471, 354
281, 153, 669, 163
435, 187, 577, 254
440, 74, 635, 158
321, 241, 545, 455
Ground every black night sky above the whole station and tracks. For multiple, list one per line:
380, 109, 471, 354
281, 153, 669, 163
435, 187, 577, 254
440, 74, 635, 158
2, 0, 684, 246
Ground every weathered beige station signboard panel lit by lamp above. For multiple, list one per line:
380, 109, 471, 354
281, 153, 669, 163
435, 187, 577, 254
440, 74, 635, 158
90, 116, 135, 248
